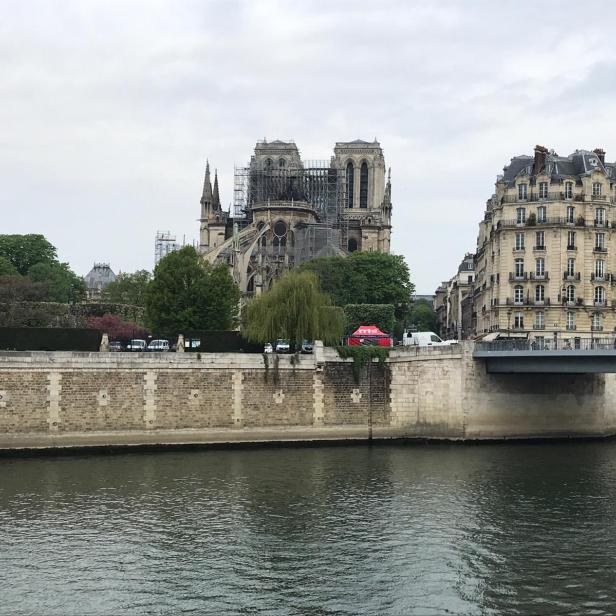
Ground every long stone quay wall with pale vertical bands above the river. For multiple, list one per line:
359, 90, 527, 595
0, 343, 616, 450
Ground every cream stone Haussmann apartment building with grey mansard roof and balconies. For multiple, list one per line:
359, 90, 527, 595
474, 146, 616, 347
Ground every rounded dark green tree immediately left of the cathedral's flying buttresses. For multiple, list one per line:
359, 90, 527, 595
145, 246, 240, 335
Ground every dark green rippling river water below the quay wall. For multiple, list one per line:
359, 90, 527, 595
0, 442, 616, 616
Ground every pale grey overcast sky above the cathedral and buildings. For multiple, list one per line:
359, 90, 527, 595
0, 0, 616, 293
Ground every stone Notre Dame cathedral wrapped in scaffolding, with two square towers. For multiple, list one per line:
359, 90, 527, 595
199, 139, 391, 295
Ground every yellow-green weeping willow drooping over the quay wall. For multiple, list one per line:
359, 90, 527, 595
243, 270, 344, 347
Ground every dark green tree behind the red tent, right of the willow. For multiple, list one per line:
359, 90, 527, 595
301, 252, 415, 319
